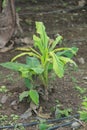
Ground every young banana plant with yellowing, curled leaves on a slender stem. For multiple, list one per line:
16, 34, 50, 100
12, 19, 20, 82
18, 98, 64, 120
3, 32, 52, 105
1, 22, 78, 101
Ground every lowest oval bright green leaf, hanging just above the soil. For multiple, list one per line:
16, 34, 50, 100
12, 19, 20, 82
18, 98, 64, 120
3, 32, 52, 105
29, 89, 39, 105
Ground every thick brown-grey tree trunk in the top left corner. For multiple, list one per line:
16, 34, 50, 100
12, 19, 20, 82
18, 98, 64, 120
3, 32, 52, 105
0, 0, 16, 48
